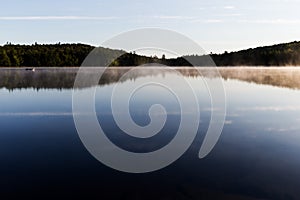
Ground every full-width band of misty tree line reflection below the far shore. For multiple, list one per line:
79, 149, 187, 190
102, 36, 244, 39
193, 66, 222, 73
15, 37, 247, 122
0, 67, 300, 90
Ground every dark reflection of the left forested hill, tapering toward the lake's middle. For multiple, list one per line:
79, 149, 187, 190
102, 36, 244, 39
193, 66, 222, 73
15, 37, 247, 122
0, 68, 155, 90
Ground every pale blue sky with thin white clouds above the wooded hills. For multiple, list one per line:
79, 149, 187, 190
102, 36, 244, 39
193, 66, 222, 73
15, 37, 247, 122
0, 0, 300, 52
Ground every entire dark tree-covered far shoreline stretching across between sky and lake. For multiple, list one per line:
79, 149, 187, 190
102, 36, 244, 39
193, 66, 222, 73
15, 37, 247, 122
0, 41, 300, 67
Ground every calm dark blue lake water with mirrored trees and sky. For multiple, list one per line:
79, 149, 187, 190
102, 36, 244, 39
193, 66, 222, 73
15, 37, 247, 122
0, 68, 300, 199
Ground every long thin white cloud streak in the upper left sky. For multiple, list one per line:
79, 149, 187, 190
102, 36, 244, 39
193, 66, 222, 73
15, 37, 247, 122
0, 16, 117, 21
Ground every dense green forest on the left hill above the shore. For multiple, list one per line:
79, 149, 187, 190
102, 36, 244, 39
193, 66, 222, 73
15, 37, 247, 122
0, 43, 125, 67
